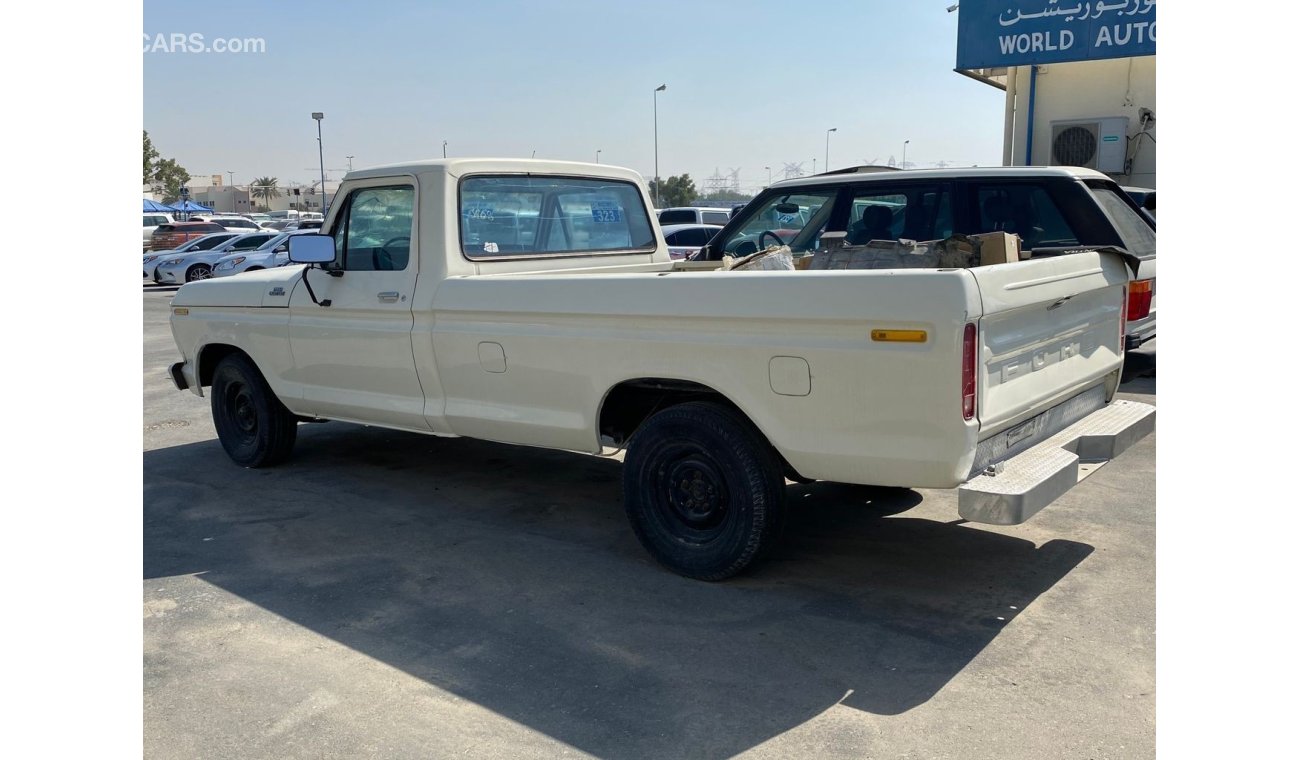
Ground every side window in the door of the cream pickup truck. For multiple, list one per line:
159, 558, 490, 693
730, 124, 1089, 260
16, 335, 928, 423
334, 184, 415, 272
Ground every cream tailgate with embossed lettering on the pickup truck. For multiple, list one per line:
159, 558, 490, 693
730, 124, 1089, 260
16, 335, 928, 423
969, 251, 1128, 446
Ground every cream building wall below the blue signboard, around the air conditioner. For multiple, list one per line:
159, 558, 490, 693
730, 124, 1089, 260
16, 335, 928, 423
1006, 56, 1160, 187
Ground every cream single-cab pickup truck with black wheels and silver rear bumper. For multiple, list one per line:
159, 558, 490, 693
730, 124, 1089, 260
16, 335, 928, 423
172, 158, 1154, 579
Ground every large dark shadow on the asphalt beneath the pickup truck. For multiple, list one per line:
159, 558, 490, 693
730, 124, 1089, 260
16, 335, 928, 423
144, 424, 1092, 757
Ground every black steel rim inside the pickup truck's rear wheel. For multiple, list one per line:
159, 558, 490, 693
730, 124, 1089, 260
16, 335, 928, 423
655, 450, 729, 543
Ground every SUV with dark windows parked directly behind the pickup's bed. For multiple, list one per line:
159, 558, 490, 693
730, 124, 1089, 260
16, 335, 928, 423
694, 166, 1156, 349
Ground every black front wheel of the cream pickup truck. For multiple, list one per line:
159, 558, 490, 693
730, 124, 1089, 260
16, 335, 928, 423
211, 353, 298, 468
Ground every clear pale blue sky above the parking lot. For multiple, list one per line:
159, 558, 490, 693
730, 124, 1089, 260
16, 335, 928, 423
144, 0, 1004, 191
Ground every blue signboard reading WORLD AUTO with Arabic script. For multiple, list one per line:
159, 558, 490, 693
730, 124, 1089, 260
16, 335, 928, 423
957, 0, 1156, 69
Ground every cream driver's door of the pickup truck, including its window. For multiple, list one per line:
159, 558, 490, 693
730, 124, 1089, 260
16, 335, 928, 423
289, 178, 429, 431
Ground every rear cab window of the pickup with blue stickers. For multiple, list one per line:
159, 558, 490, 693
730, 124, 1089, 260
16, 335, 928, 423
459, 175, 655, 259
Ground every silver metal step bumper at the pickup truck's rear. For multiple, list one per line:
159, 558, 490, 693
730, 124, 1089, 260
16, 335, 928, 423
957, 401, 1156, 525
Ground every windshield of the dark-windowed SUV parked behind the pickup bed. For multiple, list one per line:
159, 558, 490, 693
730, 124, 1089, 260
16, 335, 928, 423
714, 188, 836, 256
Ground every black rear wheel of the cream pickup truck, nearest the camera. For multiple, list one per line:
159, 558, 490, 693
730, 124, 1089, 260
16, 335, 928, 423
623, 401, 785, 581
